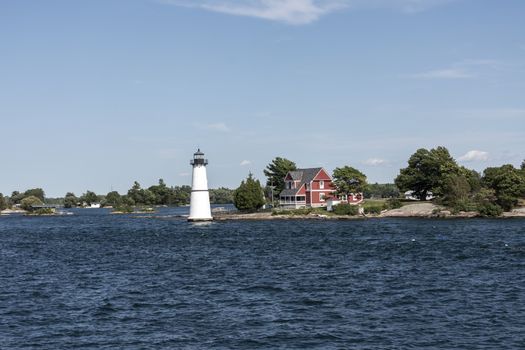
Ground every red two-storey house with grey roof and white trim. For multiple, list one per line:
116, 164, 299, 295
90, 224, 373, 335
279, 168, 335, 208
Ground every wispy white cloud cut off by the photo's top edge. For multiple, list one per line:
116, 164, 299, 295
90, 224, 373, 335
160, 0, 455, 25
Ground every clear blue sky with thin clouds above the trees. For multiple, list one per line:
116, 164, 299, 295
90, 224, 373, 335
0, 0, 525, 196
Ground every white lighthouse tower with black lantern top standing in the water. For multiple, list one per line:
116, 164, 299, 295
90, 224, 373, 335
188, 149, 213, 221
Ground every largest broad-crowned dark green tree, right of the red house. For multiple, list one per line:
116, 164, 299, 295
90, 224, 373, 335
395, 146, 460, 200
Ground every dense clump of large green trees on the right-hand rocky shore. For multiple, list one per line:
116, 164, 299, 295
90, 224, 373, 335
395, 147, 525, 216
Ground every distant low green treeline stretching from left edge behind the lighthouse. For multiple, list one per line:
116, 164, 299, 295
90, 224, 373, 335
0, 179, 233, 210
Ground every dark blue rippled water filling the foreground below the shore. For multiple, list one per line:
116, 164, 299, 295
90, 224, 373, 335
0, 208, 525, 349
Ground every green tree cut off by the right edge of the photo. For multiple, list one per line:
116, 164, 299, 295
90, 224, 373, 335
482, 164, 525, 210
